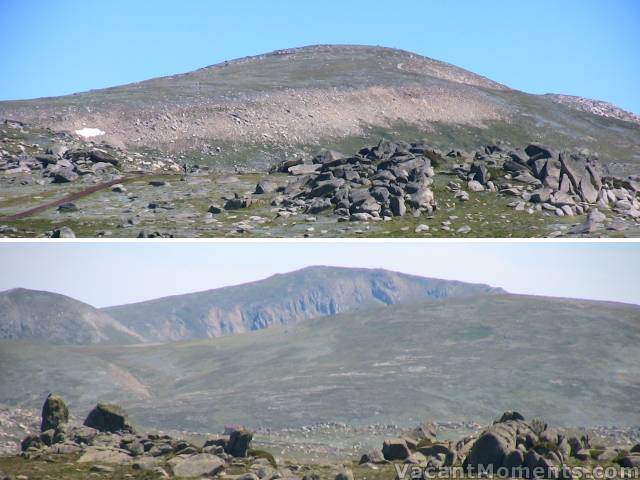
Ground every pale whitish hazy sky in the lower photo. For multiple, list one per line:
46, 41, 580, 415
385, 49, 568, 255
0, 240, 640, 307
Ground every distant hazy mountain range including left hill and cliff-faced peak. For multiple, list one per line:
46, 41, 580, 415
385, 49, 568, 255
0, 266, 503, 344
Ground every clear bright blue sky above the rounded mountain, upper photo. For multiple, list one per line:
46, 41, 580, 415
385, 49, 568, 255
0, 0, 640, 113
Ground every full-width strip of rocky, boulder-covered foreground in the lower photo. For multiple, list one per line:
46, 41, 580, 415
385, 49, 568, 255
0, 395, 640, 480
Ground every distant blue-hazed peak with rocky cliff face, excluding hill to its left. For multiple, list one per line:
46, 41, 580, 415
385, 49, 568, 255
104, 267, 503, 341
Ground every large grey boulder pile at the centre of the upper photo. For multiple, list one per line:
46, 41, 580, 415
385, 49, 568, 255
264, 140, 440, 221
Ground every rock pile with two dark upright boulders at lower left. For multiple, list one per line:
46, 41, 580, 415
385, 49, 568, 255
22, 395, 262, 479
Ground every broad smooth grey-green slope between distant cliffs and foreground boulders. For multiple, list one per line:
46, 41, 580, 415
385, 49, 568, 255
0, 295, 640, 430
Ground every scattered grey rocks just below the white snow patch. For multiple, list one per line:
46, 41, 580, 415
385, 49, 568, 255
0, 121, 181, 185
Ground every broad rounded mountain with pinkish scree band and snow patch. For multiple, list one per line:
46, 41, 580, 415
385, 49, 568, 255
0, 45, 640, 168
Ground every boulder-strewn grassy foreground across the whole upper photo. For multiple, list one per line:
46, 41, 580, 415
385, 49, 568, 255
0, 122, 640, 238
